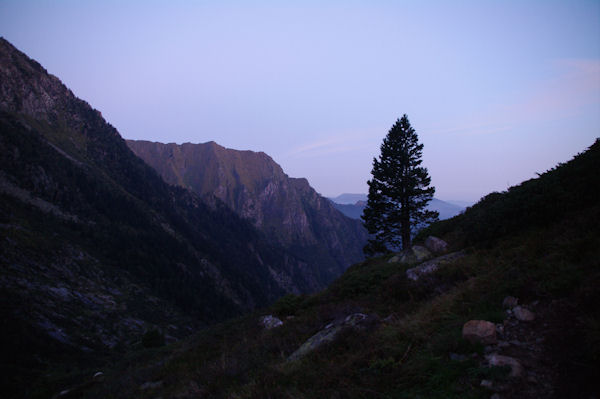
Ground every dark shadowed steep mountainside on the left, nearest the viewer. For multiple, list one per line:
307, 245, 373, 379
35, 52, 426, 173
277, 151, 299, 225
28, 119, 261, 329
0, 38, 332, 387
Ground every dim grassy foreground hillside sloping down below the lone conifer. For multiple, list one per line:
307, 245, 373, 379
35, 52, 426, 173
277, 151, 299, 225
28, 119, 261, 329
81, 142, 600, 398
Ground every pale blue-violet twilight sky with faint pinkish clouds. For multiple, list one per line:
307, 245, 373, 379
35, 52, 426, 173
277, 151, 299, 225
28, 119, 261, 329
0, 0, 600, 201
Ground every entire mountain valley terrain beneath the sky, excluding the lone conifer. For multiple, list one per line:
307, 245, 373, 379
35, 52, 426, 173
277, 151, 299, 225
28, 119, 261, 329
0, 38, 600, 399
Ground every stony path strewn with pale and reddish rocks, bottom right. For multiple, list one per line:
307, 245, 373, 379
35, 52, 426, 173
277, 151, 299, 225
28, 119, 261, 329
462, 297, 600, 399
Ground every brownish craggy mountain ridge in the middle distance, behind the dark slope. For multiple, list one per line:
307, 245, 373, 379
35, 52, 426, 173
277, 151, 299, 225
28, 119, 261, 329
127, 140, 366, 290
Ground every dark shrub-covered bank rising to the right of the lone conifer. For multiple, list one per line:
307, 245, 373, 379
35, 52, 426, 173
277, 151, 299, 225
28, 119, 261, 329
421, 139, 600, 244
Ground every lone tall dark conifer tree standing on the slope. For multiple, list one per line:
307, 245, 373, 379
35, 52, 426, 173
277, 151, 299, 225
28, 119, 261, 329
362, 114, 438, 255
